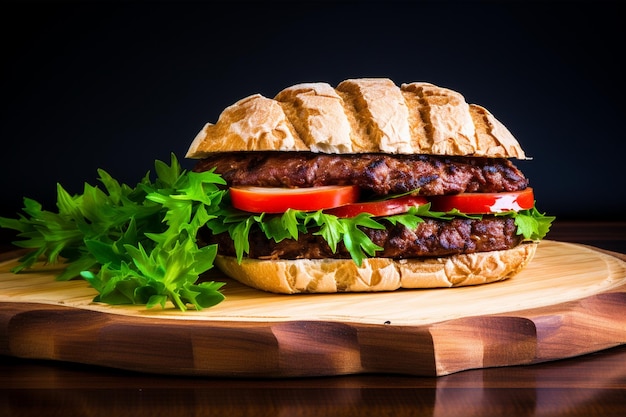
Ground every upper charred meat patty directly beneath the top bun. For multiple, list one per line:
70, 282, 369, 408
194, 152, 528, 196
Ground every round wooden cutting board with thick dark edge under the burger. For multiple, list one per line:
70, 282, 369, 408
0, 240, 626, 377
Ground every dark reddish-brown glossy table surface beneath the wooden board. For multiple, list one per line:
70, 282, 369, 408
0, 222, 626, 417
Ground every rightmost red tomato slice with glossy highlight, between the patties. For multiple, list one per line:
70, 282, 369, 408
428, 187, 535, 214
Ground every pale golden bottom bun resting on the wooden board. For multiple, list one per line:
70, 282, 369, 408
215, 242, 537, 294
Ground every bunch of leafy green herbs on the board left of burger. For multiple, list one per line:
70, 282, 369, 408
0, 154, 226, 310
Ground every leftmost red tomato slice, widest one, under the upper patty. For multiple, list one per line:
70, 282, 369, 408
230, 185, 359, 213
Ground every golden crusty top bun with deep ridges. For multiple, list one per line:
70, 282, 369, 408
186, 78, 526, 159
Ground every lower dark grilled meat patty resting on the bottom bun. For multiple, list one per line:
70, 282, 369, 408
202, 216, 522, 259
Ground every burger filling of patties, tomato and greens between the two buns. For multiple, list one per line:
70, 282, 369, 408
194, 152, 552, 264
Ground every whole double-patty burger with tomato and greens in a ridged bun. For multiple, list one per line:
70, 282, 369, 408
186, 78, 554, 294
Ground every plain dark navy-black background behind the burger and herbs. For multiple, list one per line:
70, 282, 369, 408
0, 0, 626, 245
